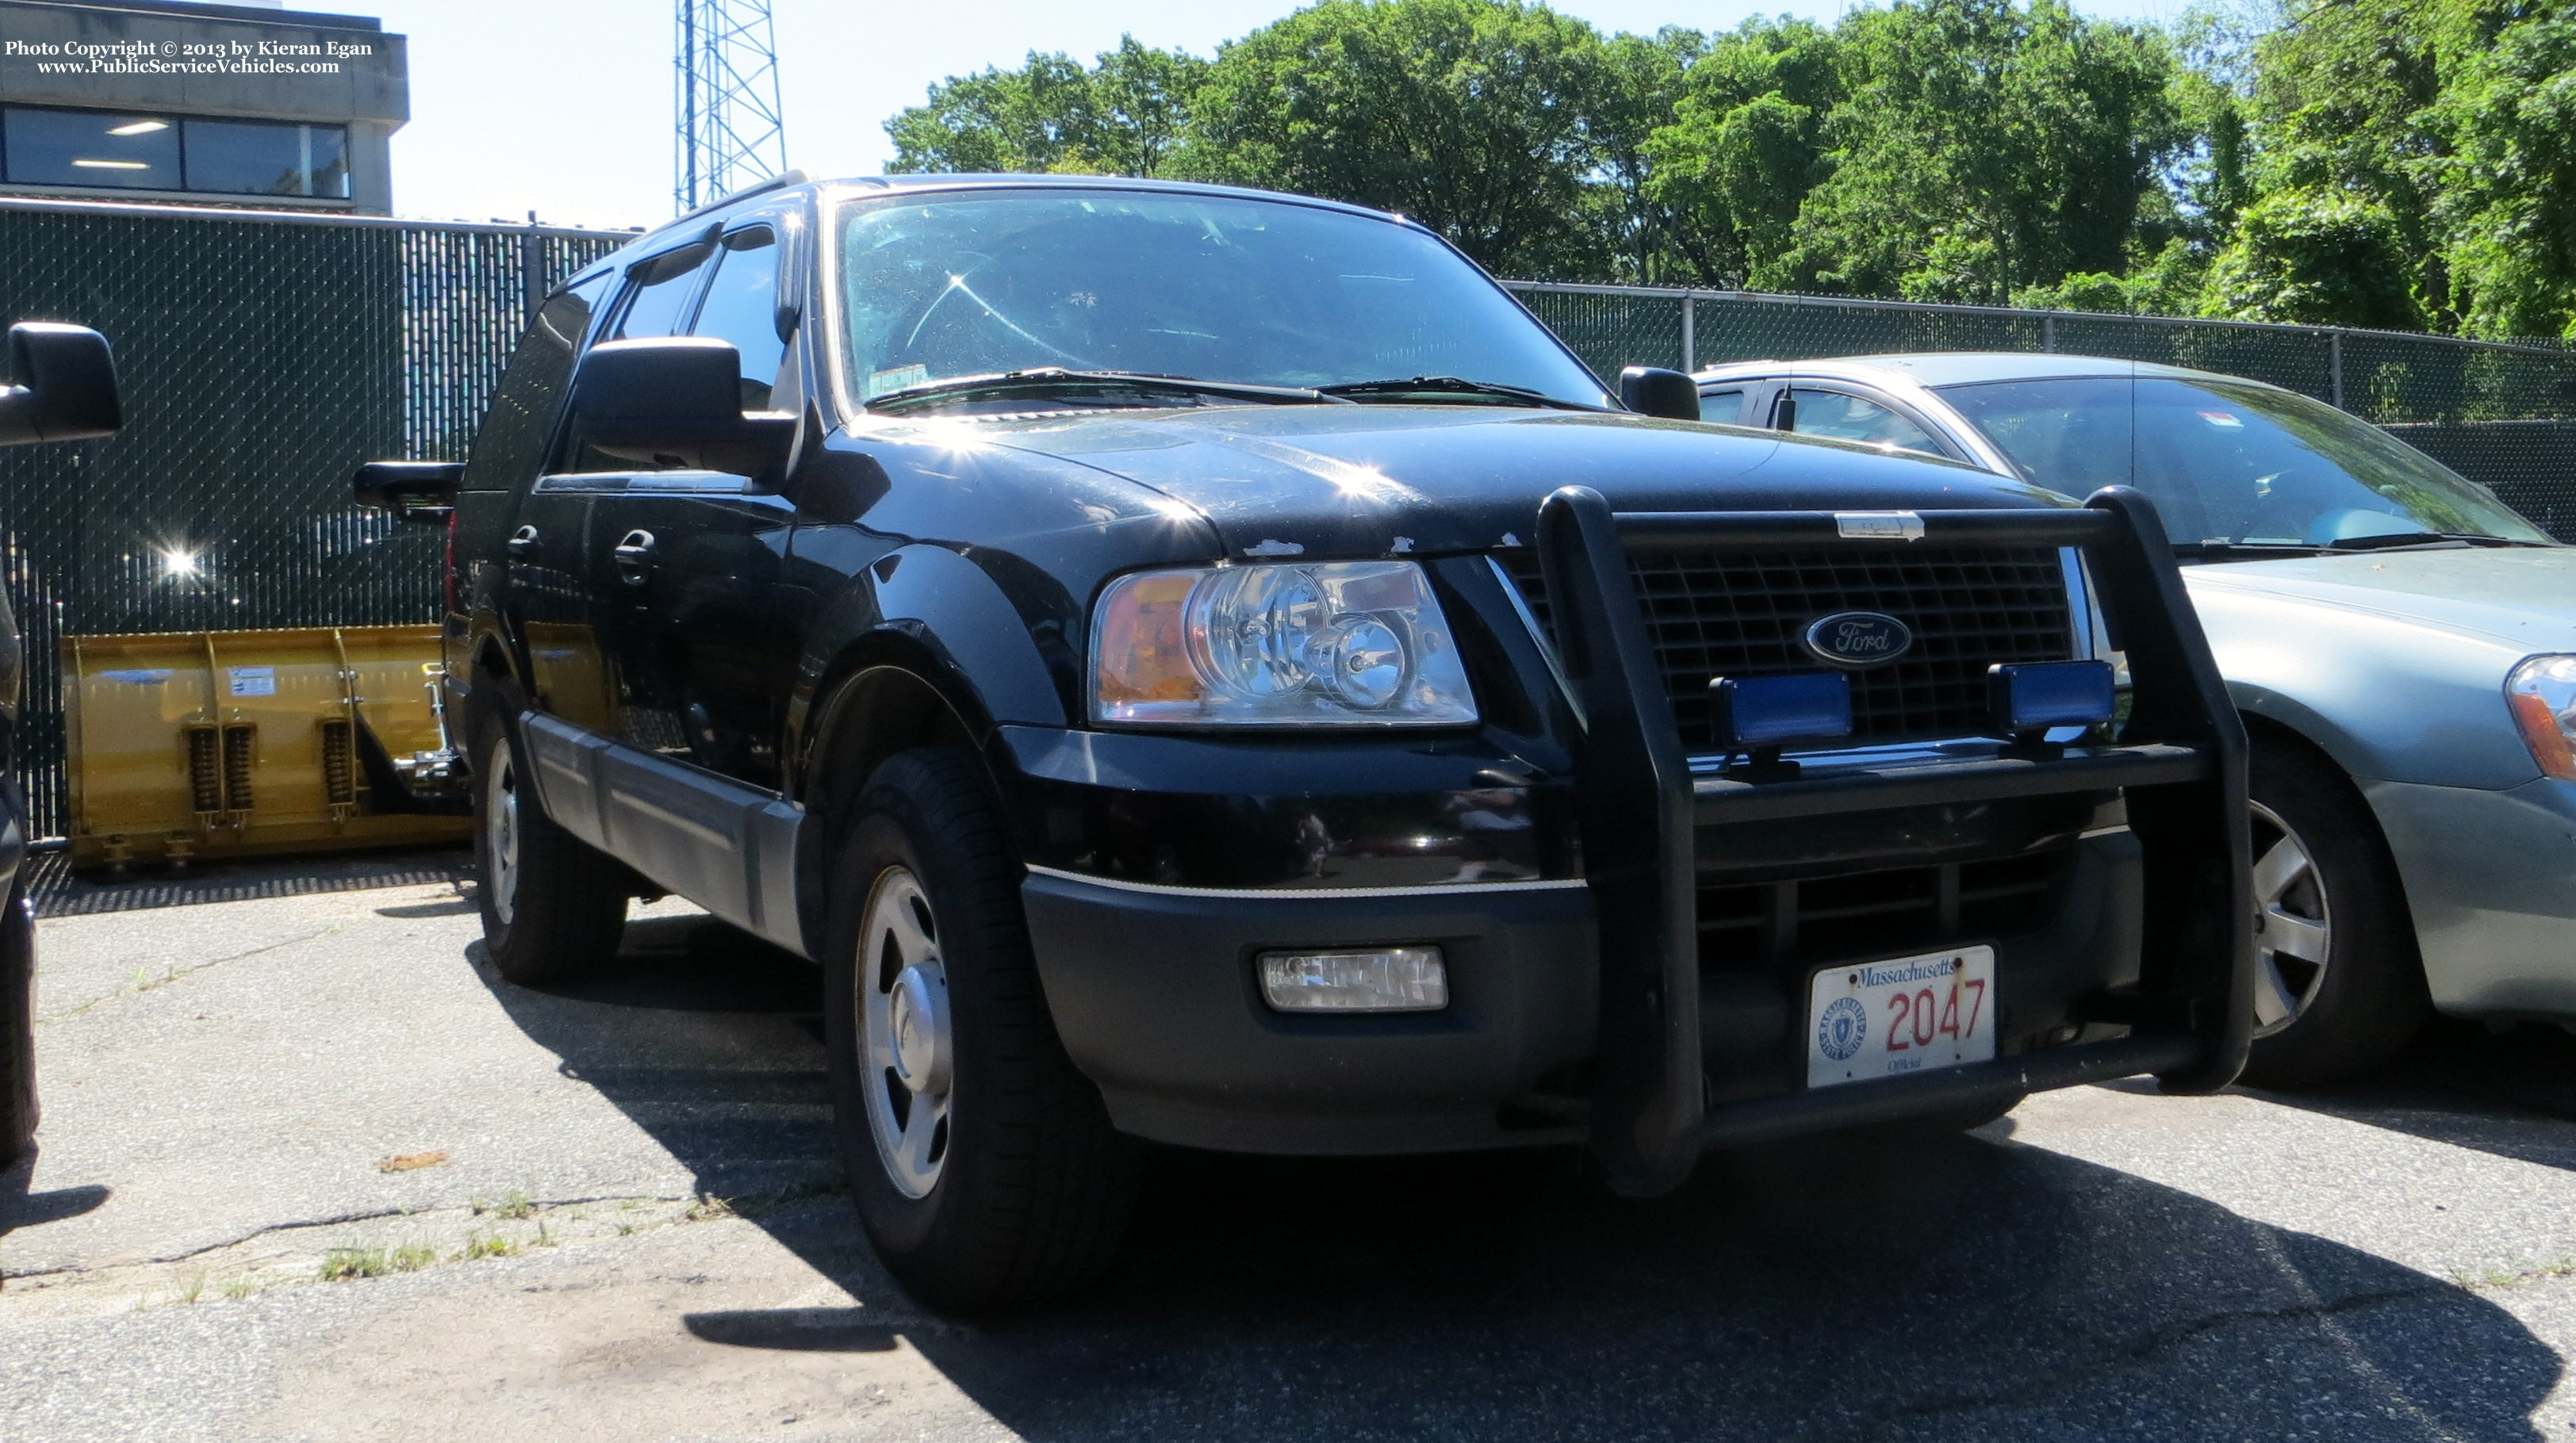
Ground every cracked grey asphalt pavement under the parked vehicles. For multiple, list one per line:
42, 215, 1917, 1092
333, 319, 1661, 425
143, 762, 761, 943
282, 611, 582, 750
0, 855, 2576, 1443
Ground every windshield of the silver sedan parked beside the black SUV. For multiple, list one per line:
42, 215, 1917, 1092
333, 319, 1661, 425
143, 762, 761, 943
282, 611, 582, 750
1940, 377, 2547, 546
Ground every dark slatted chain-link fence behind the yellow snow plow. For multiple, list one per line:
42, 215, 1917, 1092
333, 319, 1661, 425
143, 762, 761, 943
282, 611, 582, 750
0, 201, 631, 835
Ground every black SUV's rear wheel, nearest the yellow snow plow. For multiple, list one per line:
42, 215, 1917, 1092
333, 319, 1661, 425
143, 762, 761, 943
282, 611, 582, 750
471, 680, 634, 987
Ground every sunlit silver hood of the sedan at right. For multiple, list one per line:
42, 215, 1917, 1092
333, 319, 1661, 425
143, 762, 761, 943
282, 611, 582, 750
2182, 546, 2576, 652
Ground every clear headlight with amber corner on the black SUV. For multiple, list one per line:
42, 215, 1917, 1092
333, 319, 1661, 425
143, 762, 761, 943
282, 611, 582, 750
1092, 562, 1476, 727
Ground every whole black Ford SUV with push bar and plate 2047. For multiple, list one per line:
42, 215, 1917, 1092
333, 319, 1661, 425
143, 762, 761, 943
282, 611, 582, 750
361, 175, 2252, 1309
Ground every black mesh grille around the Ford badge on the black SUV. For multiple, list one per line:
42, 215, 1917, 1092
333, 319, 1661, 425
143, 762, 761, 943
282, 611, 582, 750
1502, 546, 2074, 752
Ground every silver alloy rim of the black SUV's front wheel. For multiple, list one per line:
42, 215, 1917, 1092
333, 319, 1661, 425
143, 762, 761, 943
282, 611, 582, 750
850, 866, 956, 1198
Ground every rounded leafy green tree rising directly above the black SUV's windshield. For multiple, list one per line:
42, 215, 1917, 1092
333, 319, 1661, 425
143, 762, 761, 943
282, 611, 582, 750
1180, 0, 1620, 276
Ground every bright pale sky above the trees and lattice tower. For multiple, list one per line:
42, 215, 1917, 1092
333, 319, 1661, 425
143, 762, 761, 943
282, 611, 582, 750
342, 0, 2179, 227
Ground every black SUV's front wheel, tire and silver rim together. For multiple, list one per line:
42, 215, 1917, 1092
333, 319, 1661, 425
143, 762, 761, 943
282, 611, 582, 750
824, 748, 1136, 1315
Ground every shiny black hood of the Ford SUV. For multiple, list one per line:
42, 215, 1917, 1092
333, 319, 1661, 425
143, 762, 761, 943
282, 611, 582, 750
943, 404, 2066, 557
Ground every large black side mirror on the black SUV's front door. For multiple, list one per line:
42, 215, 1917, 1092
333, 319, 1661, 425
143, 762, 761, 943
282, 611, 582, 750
572, 335, 796, 480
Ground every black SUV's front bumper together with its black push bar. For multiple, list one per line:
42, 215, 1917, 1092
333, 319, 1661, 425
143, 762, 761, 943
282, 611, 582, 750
1014, 490, 2254, 1193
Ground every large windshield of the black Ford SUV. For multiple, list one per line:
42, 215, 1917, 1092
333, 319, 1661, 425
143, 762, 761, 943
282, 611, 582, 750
840, 191, 1608, 404
